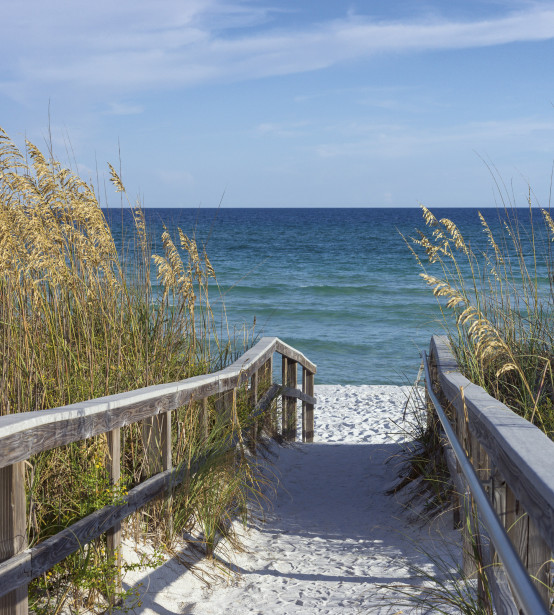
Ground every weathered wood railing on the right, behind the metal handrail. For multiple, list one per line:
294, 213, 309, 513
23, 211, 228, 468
429, 336, 554, 615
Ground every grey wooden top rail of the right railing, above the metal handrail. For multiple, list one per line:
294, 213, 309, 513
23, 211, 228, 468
431, 336, 554, 550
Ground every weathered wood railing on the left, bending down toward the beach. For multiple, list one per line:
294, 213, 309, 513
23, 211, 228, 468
0, 337, 316, 615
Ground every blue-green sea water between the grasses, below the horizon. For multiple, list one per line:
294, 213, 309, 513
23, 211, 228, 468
101, 208, 544, 384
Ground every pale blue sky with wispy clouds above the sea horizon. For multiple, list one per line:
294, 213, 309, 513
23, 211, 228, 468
0, 0, 554, 208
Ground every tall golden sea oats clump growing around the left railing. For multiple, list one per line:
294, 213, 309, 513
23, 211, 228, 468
0, 129, 268, 614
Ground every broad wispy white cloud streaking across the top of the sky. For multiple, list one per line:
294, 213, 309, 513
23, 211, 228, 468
0, 0, 554, 97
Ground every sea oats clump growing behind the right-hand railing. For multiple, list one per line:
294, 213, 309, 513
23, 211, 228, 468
405, 199, 554, 438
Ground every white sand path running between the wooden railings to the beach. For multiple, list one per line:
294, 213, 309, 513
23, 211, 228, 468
125, 385, 459, 615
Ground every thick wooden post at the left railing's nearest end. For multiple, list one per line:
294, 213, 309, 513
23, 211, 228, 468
0, 461, 29, 615
